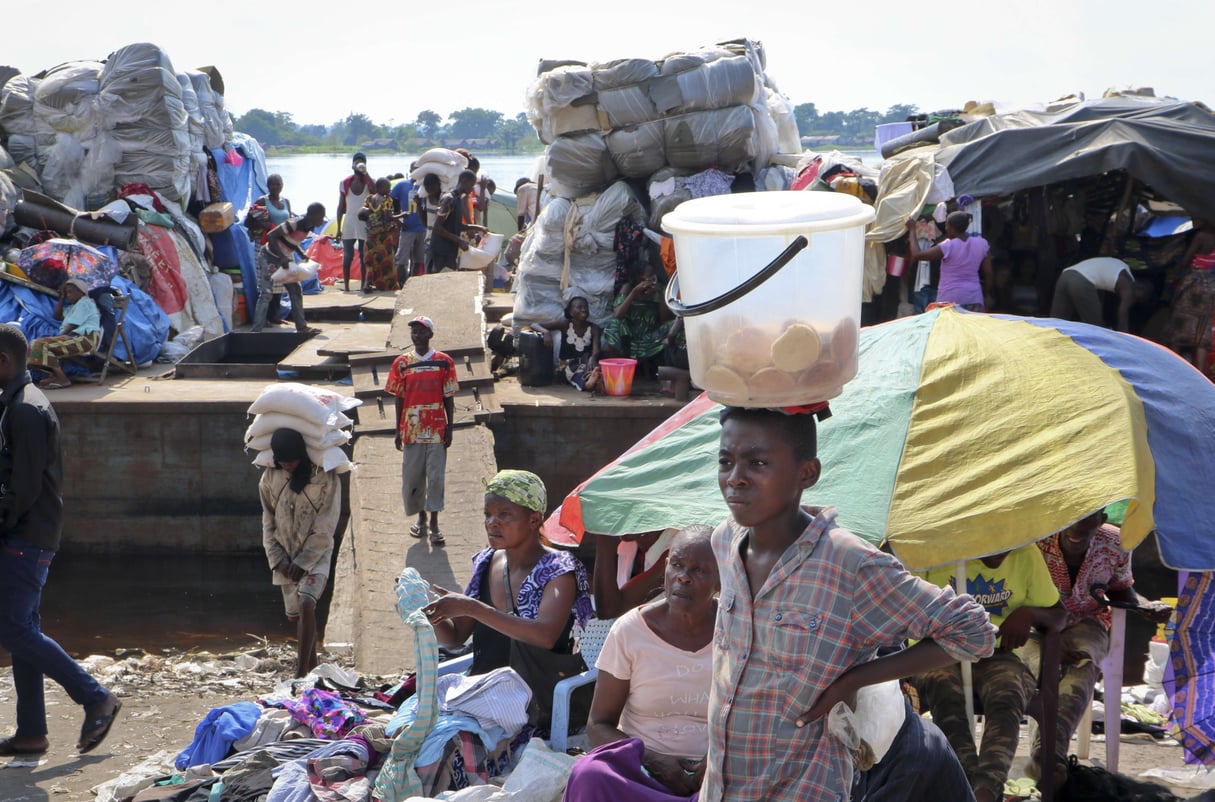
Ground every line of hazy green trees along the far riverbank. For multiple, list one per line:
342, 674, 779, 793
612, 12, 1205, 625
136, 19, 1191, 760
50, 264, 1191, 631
236, 103, 919, 153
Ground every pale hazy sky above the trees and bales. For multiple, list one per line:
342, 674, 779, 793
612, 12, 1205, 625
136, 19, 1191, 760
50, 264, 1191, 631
7, 0, 1215, 124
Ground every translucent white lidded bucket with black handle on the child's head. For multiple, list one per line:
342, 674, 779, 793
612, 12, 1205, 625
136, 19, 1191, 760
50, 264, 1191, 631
662, 192, 874, 407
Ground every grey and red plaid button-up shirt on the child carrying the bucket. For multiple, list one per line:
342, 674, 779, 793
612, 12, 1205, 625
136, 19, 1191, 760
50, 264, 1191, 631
700, 508, 995, 802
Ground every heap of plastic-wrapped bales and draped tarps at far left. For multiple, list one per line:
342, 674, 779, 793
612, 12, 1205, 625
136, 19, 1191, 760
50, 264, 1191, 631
0, 43, 267, 347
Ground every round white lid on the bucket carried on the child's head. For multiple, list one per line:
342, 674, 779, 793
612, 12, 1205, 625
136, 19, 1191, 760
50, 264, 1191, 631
662, 191, 875, 237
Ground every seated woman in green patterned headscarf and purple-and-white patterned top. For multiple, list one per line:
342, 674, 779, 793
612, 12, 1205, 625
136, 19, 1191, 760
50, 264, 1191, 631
425, 470, 590, 730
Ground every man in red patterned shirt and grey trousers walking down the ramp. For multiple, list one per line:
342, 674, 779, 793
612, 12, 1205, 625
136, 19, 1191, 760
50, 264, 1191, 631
384, 315, 456, 546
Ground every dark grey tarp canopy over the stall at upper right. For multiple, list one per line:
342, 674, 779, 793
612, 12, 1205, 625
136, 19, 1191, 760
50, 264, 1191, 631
934, 97, 1215, 219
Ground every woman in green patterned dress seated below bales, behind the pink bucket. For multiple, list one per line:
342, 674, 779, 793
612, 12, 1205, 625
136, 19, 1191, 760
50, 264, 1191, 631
603, 259, 674, 379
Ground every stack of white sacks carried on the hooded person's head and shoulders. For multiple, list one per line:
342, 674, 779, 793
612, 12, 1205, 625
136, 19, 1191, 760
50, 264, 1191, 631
244, 382, 362, 474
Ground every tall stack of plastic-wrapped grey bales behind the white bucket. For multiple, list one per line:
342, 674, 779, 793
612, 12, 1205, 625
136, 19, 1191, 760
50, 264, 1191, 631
514, 39, 802, 331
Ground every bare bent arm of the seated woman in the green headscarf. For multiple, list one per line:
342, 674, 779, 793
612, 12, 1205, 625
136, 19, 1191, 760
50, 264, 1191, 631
425, 571, 577, 649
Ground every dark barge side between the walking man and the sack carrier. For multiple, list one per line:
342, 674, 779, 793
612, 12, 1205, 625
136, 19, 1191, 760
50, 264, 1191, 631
56, 401, 261, 559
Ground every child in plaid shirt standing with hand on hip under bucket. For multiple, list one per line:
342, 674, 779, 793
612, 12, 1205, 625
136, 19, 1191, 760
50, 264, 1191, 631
700, 407, 995, 802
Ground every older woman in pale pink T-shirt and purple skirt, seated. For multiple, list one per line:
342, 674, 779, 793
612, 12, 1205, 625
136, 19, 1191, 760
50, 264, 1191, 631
565, 525, 720, 802
